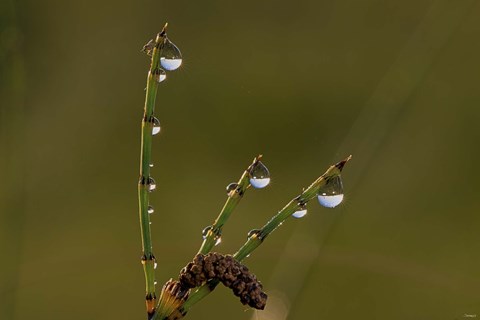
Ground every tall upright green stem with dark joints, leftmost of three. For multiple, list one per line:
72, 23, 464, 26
138, 24, 167, 318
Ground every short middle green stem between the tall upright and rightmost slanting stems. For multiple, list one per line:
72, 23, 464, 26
198, 155, 262, 254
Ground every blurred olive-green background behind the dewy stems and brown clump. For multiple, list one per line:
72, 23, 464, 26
0, 0, 480, 320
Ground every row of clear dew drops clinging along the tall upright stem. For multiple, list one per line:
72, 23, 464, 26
147, 38, 182, 224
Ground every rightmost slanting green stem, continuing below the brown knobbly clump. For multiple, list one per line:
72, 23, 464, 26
180, 156, 352, 314
